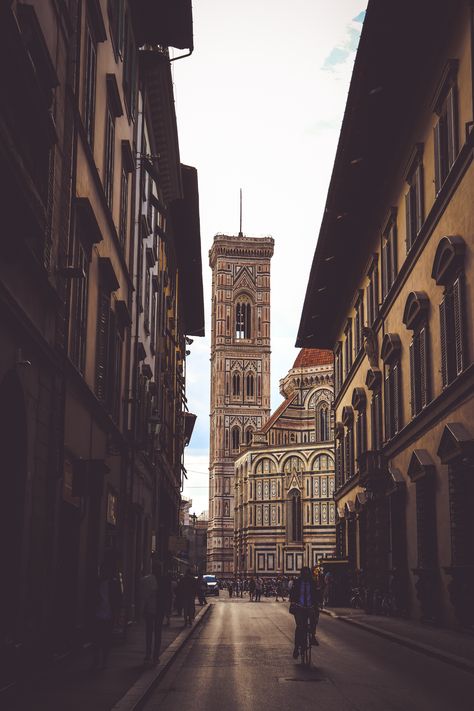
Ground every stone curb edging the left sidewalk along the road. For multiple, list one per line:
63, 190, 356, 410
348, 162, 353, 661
110, 603, 211, 711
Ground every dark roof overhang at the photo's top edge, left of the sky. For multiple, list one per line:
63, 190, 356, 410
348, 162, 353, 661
130, 0, 193, 50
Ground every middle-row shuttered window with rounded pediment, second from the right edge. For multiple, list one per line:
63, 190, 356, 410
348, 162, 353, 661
403, 291, 430, 417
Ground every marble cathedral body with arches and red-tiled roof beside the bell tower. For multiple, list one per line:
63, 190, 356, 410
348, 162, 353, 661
234, 349, 336, 578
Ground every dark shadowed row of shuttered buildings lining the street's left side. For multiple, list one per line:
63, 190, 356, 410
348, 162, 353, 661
0, 0, 204, 687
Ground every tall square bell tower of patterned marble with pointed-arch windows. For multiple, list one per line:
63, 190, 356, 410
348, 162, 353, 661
208, 234, 274, 577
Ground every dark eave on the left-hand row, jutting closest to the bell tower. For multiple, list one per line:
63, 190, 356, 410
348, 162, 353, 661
169, 165, 204, 336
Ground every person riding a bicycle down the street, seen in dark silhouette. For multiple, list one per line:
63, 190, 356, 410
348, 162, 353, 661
290, 566, 321, 659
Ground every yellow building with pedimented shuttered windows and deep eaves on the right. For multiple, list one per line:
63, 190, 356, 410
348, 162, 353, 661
298, 2, 474, 629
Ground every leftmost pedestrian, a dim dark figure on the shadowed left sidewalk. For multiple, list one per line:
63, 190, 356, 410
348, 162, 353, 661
93, 549, 123, 669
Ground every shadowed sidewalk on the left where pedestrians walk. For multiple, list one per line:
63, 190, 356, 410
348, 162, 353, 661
0, 605, 209, 711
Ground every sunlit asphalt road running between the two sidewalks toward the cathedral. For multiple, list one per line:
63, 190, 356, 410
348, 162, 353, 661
144, 596, 474, 711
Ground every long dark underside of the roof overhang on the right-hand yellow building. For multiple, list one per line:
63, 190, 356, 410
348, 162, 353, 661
296, 0, 459, 348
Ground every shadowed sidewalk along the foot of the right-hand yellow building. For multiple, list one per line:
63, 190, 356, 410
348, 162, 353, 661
322, 607, 474, 674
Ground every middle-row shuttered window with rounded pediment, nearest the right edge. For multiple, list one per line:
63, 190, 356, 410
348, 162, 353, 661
431, 237, 469, 388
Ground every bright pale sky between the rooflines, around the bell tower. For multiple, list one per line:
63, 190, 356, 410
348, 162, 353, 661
172, 0, 367, 515
